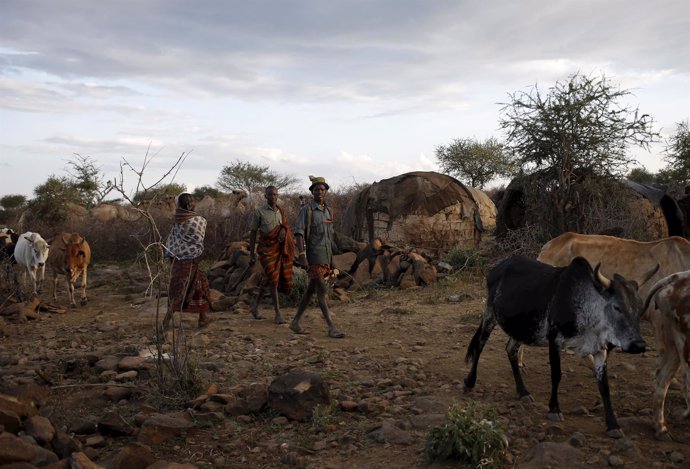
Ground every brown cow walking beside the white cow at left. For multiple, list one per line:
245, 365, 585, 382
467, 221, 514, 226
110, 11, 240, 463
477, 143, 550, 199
47, 233, 91, 308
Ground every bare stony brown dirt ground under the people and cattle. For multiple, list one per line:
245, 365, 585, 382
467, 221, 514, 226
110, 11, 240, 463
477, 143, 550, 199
0, 265, 690, 468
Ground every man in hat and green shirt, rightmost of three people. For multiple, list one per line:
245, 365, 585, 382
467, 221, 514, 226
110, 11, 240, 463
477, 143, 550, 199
290, 176, 345, 339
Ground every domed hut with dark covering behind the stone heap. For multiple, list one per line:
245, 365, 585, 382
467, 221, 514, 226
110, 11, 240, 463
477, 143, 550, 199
342, 171, 496, 252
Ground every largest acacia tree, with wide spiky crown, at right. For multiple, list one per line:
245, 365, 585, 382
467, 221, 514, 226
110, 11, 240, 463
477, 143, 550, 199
500, 73, 659, 233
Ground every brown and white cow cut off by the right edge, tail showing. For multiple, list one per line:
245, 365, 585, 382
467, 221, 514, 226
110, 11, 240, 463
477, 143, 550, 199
644, 270, 690, 440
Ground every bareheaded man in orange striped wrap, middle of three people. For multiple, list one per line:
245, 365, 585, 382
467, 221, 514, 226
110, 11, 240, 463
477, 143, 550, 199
249, 186, 295, 324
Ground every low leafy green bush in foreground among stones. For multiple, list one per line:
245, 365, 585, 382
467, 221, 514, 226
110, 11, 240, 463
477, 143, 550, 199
424, 401, 508, 468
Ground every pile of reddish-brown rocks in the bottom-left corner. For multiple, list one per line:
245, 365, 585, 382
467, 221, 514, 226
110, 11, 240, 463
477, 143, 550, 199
0, 378, 196, 469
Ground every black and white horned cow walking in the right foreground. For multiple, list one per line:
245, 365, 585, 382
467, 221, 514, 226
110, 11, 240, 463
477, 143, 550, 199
465, 256, 658, 438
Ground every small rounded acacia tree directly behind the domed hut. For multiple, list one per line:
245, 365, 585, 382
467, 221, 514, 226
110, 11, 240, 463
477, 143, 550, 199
436, 138, 516, 189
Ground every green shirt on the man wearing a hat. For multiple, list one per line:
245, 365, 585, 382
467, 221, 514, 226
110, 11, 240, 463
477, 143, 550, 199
295, 200, 333, 265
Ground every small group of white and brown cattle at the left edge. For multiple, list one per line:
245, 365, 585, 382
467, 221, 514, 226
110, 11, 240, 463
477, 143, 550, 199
0, 228, 91, 307
